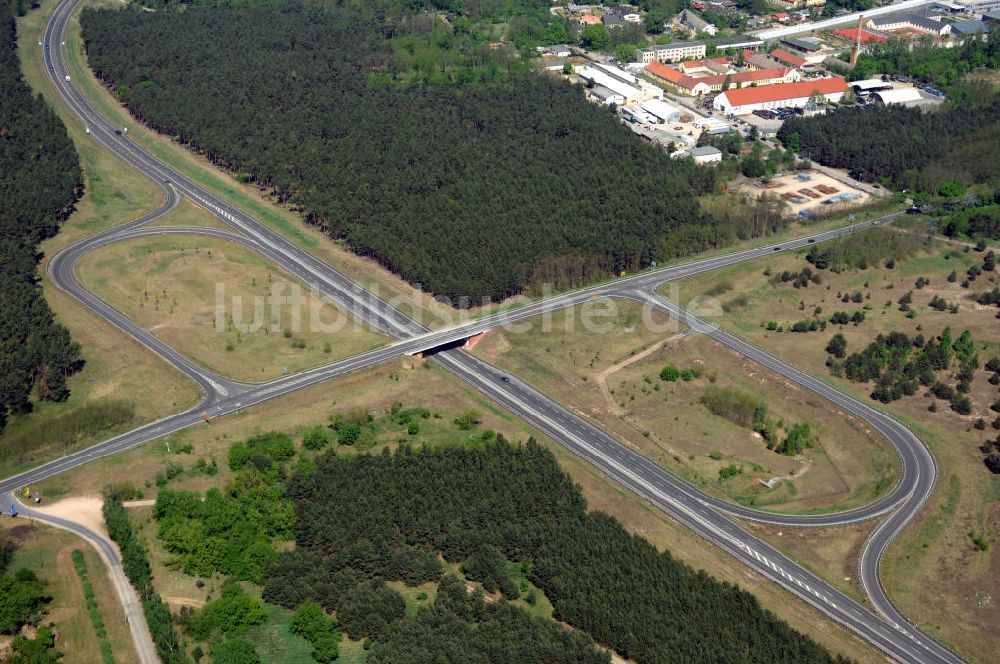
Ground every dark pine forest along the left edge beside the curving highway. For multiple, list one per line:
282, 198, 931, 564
0, 2, 83, 429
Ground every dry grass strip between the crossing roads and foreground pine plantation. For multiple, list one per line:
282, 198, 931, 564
38, 359, 883, 662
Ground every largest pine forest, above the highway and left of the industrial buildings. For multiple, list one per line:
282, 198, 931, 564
82, 3, 737, 299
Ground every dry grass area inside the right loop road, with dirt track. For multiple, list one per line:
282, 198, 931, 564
476, 301, 896, 511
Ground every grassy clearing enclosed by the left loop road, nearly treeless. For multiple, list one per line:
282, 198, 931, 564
77, 231, 386, 382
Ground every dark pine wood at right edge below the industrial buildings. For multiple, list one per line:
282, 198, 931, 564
778, 89, 1000, 193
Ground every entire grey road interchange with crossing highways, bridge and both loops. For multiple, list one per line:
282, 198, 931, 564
0, 0, 960, 662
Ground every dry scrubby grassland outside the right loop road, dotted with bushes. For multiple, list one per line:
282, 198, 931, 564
664, 232, 1000, 661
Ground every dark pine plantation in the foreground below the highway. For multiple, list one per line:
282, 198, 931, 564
254, 438, 839, 664
